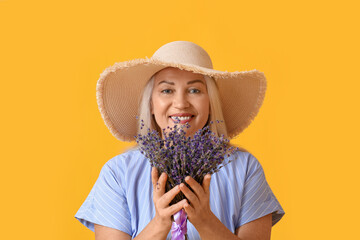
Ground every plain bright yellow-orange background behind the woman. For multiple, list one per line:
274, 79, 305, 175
0, 0, 360, 240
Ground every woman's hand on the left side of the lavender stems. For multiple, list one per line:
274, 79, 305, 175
151, 167, 186, 233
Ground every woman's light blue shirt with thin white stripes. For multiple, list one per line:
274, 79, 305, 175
75, 149, 285, 240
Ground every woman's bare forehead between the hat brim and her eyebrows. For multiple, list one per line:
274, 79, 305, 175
155, 67, 205, 82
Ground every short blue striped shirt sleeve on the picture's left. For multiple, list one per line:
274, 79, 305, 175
75, 158, 131, 236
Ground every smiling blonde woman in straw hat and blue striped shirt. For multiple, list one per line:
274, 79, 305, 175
75, 41, 284, 240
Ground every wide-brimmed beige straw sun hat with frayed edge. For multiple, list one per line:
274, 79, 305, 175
96, 41, 266, 141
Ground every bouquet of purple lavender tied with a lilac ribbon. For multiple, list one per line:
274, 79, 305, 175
135, 120, 237, 239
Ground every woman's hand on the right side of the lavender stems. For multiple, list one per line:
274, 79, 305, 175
180, 174, 215, 229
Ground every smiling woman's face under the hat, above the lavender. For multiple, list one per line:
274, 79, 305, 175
151, 67, 210, 136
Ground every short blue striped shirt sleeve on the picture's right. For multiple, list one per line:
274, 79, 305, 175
236, 154, 285, 228
